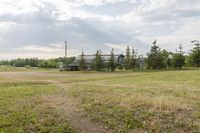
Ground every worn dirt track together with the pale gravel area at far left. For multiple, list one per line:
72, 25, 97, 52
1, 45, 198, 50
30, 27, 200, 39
0, 72, 112, 133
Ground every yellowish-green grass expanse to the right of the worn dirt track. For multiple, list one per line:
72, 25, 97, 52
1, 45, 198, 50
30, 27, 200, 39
70, 71, 200, 132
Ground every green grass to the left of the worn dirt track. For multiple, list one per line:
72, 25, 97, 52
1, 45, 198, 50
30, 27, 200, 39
0, 82, 74, 133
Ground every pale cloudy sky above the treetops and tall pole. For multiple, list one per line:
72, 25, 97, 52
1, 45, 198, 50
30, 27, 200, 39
0, 0, 200, 59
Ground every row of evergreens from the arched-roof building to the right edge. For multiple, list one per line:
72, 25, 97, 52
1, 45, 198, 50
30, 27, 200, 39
79, 40, 200, 71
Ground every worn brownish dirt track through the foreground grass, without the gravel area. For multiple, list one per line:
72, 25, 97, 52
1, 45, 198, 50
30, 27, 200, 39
50, 81, 111, 133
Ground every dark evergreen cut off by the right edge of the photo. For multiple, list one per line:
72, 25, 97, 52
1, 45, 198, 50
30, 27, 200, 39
188, 40, 200, 67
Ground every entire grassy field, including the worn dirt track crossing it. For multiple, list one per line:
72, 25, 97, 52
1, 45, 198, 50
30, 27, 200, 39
0, 69, 200, 133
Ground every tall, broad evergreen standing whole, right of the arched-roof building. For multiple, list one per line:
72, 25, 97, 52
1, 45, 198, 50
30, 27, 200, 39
146, 40, 164, 69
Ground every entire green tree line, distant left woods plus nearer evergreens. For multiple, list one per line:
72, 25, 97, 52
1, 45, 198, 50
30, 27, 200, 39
0, 40, 200, 71
